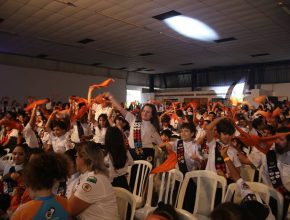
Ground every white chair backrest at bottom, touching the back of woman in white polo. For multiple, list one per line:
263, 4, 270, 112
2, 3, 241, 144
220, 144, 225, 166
114, 187, 136, 220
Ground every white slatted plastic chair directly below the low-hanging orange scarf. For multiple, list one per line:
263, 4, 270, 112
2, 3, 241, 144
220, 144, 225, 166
135, 169, 183, 219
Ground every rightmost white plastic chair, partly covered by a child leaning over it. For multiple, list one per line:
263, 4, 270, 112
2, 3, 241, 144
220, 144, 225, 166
224, 182, 284, 220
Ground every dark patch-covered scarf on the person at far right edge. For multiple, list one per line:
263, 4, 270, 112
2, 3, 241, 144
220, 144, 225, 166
266, 150, 290, 200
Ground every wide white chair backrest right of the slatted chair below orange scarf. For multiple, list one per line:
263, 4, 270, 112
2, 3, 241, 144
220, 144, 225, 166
177, 170, 227, 216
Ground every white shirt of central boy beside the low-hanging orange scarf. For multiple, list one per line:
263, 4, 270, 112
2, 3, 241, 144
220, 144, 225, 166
173, 140, 203, 172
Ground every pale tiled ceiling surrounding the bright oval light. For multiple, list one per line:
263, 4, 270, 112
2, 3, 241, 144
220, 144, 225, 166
0, 0, 290, 73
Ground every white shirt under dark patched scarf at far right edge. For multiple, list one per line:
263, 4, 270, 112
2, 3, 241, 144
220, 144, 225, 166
261, 151, 290, 191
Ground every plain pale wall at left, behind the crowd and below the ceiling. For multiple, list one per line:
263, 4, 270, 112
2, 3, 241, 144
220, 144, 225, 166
0, 64, 126, 102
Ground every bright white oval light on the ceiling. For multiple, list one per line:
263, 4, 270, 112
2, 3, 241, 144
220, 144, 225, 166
164, 15, 219, 41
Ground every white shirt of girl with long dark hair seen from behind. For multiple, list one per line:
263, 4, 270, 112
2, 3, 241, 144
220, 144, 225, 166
104, 151, 134, 182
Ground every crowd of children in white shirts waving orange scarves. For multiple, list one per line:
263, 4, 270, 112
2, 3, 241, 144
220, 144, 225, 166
0, 87, 290, 220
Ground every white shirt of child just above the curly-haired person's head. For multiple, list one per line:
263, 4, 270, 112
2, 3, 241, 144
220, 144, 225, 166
48, 132, 71, 153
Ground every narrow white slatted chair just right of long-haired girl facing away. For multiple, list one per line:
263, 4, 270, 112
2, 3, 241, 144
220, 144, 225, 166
128, 160, 152, 208
